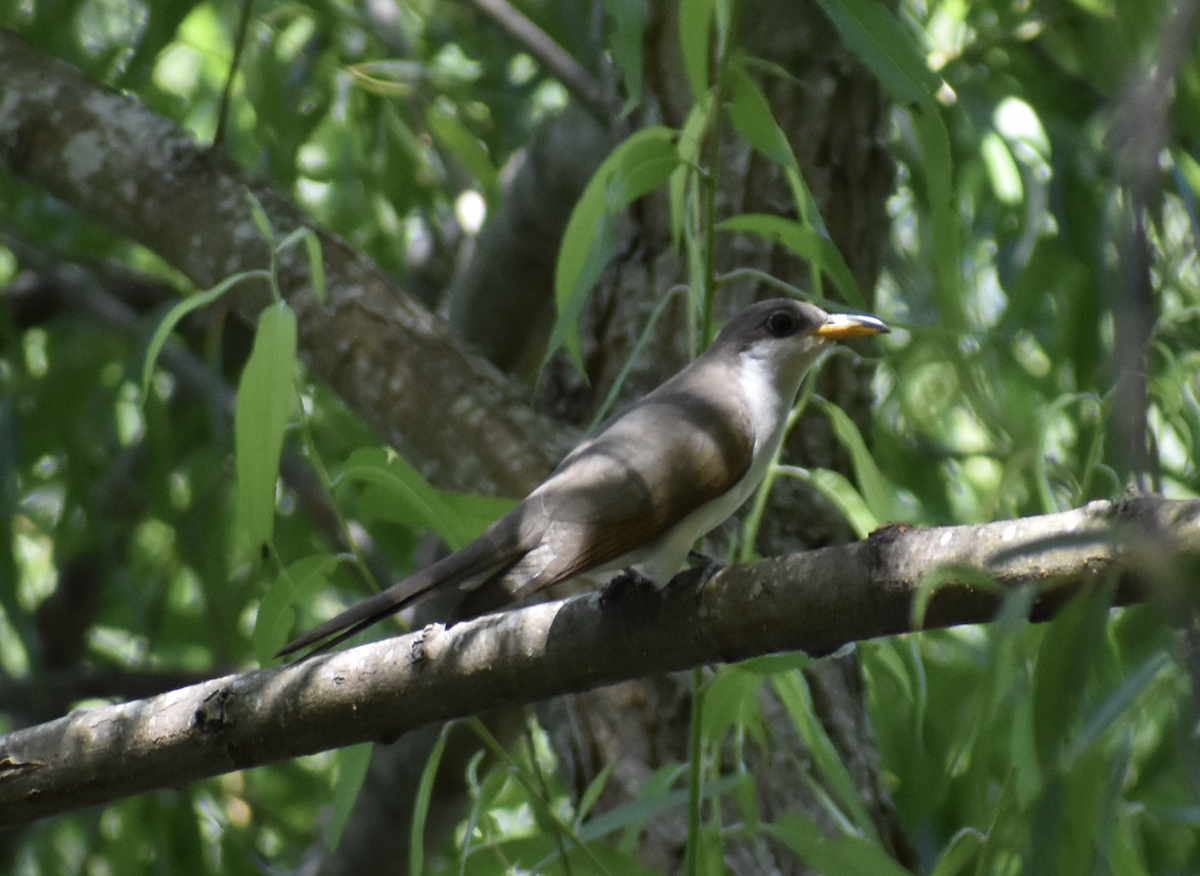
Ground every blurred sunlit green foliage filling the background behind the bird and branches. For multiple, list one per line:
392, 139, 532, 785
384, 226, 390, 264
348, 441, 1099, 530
0, 0, 1200, 874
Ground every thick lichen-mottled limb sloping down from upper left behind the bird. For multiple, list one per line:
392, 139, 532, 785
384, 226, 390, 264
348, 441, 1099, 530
0, 28, 569, 497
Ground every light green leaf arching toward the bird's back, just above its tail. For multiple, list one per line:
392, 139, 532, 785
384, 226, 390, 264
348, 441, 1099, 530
338, 448, 473, 551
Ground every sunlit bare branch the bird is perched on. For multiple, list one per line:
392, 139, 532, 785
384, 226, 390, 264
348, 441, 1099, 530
0, 497, 1200, 824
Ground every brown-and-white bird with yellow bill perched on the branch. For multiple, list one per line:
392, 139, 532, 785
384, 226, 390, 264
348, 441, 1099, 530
276, 298, 889, 656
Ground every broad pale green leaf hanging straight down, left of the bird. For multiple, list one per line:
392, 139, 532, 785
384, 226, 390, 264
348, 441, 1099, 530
234, 304, 296, 551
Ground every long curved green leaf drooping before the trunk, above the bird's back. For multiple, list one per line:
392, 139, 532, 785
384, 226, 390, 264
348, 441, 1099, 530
546, 127, 679, 364
